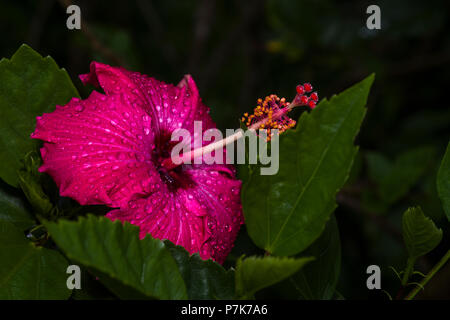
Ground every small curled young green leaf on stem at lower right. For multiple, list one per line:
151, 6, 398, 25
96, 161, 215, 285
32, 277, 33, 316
402, 207, 442, 260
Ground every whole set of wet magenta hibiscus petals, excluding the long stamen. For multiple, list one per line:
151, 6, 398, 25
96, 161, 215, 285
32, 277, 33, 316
31, 62, 243, 263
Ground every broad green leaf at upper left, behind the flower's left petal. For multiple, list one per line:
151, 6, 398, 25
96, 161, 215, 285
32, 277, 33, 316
0, 45, 78, 187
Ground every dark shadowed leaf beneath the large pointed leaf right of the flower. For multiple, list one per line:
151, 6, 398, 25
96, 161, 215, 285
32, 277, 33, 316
289, 215, 341, 300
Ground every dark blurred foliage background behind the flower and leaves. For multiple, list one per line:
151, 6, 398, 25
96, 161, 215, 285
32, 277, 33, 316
0, 0, 450, 299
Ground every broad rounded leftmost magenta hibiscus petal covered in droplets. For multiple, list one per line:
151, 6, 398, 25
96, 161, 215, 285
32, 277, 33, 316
32, 91, 160, 207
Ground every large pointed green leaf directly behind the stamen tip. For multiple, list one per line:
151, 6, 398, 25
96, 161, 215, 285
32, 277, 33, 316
242, 75, 374, 255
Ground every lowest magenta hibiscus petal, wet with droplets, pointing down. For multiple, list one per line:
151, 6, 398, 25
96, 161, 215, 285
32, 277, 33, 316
107, 166, 243, 263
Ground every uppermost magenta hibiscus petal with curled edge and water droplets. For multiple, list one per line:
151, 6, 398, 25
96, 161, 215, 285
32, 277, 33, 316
80, 62, 215, 148
